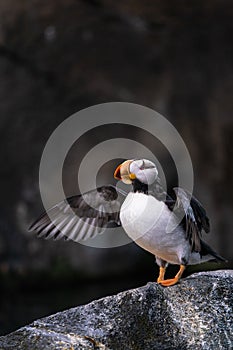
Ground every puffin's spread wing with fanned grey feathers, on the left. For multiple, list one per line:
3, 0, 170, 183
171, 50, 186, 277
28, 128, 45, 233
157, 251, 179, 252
29, 186, 126, 242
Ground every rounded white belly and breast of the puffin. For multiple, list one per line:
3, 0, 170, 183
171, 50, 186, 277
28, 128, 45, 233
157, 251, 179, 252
120, 193, 187, 264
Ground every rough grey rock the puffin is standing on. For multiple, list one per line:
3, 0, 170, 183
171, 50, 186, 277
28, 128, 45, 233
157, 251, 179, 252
0, 270, 233, 350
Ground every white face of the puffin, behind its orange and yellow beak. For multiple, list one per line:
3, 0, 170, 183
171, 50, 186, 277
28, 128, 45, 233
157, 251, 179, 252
129, 159, 158, 185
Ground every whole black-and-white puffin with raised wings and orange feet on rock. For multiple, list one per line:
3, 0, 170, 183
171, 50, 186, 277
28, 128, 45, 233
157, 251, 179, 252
29, 159, 226, 287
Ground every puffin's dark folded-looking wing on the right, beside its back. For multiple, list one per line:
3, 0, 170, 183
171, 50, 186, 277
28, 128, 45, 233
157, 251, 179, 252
173, 187, 210, 252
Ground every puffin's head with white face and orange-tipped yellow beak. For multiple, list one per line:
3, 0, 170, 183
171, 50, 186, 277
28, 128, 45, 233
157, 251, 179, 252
114, 159, 158, 185
